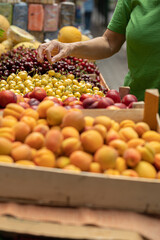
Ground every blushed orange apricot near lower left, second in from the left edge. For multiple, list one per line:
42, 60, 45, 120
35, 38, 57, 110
11, 144, 32, 161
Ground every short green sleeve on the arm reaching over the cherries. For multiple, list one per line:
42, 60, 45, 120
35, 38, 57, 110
107, 0, 132, 34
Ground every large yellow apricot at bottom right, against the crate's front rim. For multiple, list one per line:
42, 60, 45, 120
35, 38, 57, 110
134, 161, 157, 178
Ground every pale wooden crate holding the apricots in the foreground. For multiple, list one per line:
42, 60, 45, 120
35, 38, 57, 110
0, 90, 160, 214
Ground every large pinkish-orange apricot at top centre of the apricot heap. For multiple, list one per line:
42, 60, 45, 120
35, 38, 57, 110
62, 109, 85, 132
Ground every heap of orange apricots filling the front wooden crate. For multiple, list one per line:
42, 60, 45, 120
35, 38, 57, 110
0, 103, 160, 179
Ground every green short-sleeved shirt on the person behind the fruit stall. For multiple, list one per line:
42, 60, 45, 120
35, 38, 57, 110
108, 0, 160, 100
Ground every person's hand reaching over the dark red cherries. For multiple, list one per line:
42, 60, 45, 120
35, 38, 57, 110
37, 40, 72, 63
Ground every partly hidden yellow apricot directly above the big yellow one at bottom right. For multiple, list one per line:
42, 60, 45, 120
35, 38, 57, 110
136, 143, 155, 163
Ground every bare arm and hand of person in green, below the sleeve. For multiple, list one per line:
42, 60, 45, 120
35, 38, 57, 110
37, 29, 125, 63
